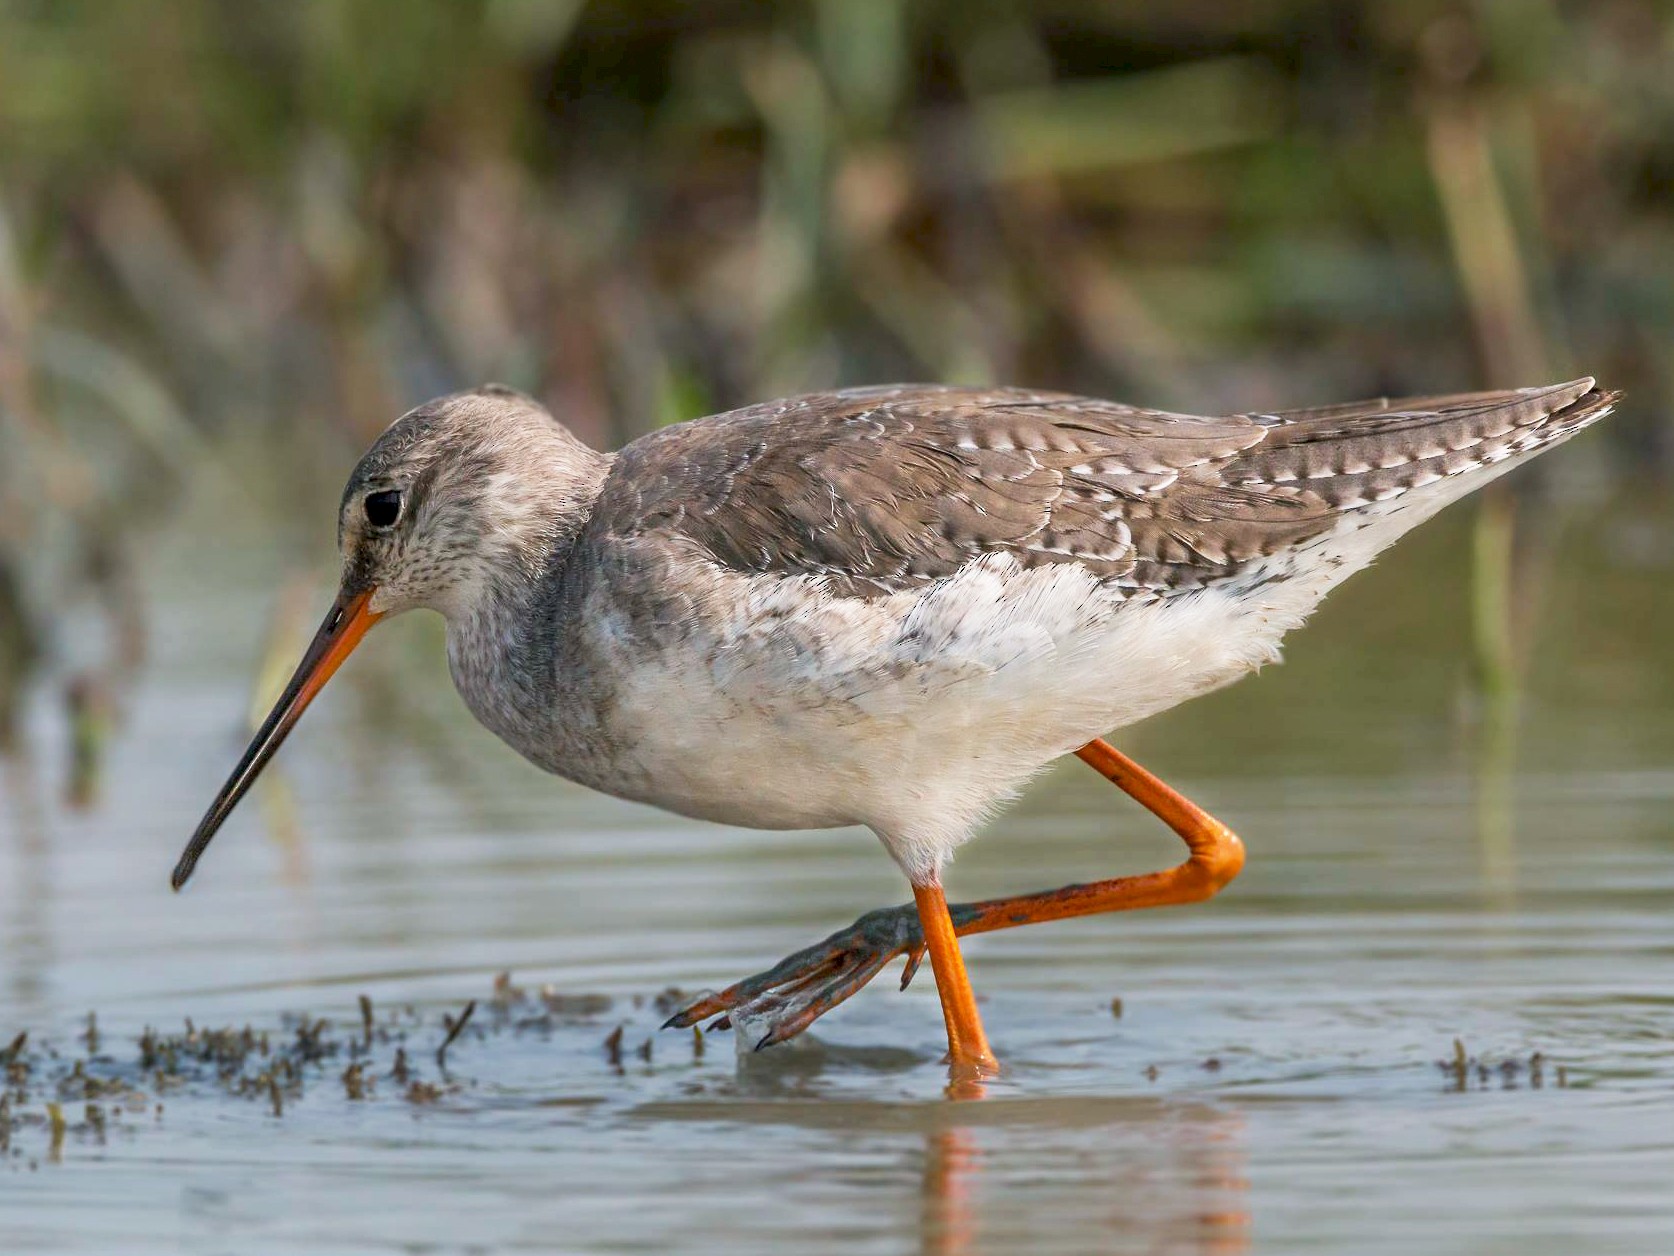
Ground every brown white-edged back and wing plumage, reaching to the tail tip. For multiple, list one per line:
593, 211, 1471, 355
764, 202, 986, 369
589, 380, 1597, 596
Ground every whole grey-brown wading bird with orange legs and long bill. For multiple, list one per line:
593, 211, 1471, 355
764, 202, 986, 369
174, 378, 1617, 1075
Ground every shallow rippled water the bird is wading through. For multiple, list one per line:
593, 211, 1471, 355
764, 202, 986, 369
0, 485, 1674, 1253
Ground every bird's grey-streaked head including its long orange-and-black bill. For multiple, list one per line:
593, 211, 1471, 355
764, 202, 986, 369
172, 385, 609, 889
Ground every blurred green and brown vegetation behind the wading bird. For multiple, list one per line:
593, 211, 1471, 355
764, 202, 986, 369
0, 0, 1674, 763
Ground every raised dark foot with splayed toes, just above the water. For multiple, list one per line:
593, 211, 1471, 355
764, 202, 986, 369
663, 904, 924, 1052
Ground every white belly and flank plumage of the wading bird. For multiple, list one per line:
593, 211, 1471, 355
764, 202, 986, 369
579, 556, 1311, 871
